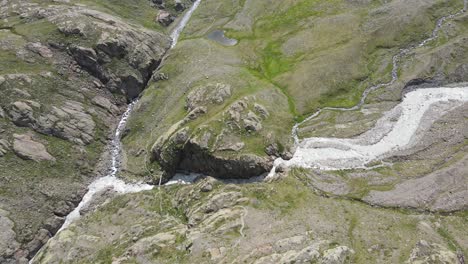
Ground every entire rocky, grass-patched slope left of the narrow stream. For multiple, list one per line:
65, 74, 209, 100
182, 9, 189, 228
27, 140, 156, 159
0, 0, 190, 263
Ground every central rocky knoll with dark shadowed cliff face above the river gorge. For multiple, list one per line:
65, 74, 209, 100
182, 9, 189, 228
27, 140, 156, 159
151, 83, 279, 183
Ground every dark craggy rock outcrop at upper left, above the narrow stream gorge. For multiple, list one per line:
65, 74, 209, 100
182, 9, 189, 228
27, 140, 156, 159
17, 2, 171, 100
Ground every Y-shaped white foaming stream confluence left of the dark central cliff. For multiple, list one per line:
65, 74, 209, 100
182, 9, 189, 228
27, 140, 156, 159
59, 101, 153, 232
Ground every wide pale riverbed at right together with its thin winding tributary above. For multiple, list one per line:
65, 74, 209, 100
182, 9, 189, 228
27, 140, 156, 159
269, 5, 468, 177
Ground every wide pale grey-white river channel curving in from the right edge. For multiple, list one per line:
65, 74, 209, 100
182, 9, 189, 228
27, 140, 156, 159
269, 87, 468, 172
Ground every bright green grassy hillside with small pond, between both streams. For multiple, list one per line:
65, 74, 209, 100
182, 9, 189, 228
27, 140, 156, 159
124, 0, 463, 180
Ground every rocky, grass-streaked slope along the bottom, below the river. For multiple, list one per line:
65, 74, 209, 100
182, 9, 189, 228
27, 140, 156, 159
36, 174, 468, 264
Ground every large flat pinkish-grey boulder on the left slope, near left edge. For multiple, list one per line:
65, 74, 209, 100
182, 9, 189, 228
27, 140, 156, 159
13, 134, 55, 162
